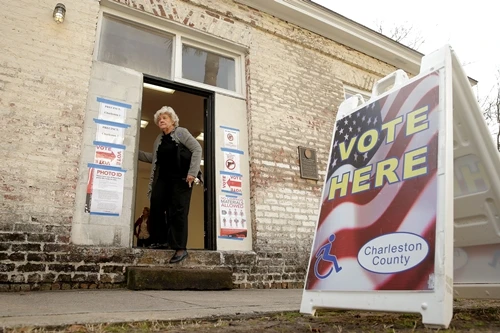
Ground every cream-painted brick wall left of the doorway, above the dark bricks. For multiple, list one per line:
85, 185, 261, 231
0, 0, 99, 228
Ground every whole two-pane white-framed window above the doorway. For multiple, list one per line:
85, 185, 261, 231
96, 10, 245, 97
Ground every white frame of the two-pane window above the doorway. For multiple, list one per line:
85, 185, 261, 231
93, 5, 246, 99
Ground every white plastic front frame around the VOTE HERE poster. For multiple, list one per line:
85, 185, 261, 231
300, 46, 454, 327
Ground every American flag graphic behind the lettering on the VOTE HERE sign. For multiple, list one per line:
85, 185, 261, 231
305, 72, 439, 291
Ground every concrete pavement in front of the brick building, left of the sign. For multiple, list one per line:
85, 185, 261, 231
0, 289, 302, 331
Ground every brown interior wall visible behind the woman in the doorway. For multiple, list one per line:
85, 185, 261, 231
134, 88, 205, 249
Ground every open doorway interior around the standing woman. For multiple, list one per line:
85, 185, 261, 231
134, 81, 207, 249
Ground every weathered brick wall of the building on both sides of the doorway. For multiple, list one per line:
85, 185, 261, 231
0, 0, 394, 290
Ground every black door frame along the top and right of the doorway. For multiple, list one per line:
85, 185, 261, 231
143, 74, 217, 250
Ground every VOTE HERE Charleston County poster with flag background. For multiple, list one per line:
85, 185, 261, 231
305, 72, 440, 291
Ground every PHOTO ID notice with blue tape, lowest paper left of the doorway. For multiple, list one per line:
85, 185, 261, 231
85, 164, 125, 216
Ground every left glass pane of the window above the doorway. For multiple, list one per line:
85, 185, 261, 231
98, 17, 173, 79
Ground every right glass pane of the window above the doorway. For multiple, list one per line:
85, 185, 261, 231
182, 44, 236, 91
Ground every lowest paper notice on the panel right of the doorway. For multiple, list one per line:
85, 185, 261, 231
219, 195, 248, 238
